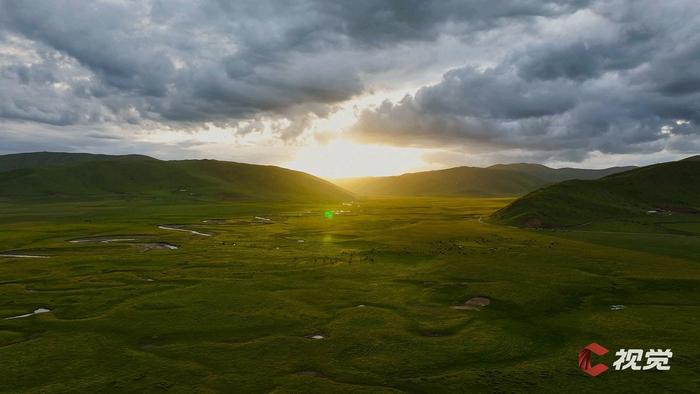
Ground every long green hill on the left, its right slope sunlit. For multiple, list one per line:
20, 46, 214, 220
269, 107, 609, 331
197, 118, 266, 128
0, 152, 352, 201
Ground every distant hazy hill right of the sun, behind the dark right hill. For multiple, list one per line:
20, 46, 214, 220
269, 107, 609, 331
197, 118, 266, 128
335, 164, 633, 197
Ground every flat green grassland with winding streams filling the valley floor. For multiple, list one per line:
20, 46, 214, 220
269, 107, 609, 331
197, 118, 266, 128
0, 198, 700, 393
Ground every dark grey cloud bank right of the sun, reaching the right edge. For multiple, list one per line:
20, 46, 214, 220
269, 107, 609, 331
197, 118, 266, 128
351, 1, 700, 161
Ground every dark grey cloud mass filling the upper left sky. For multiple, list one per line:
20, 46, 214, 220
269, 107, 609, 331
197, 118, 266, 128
0, 0, 580, 134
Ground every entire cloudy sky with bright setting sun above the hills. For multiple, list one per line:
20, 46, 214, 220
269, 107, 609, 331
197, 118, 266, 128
0, 0, 700, 178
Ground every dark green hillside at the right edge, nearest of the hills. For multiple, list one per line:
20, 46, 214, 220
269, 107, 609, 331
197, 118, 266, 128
492, 156, 700, 227
